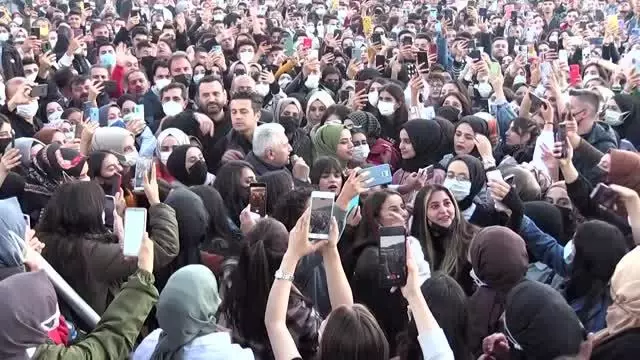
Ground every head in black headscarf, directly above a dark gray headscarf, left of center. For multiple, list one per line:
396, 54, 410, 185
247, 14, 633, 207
167, 145, 210, 186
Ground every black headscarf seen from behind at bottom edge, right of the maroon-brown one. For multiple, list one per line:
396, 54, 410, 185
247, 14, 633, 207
504, 280, 586, 359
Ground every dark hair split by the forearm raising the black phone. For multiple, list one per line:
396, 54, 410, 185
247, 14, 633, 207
398, 272, 472, 360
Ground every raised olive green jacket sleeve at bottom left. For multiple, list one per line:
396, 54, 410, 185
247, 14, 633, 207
32, 270, 158, 360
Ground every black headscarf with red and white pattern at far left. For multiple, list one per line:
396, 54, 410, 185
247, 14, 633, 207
25, 143, 87, 195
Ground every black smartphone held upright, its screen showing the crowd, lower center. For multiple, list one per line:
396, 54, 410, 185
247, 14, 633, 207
378, 226, 407, 288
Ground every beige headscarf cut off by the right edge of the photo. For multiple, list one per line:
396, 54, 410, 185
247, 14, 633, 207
594, 247, 640, 346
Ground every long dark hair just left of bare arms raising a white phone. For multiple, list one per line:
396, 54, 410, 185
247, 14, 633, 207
220, 218, 293, 356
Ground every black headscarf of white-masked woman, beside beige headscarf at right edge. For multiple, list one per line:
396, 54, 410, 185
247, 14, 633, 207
566, 220, 629, 326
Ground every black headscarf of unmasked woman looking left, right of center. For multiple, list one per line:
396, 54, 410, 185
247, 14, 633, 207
400, 120, 446, 172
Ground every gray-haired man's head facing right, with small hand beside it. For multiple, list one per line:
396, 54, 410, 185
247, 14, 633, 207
245, 123, 309, 182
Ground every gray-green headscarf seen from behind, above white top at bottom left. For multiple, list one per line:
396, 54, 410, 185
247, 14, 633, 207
150, 265, 220, 360
